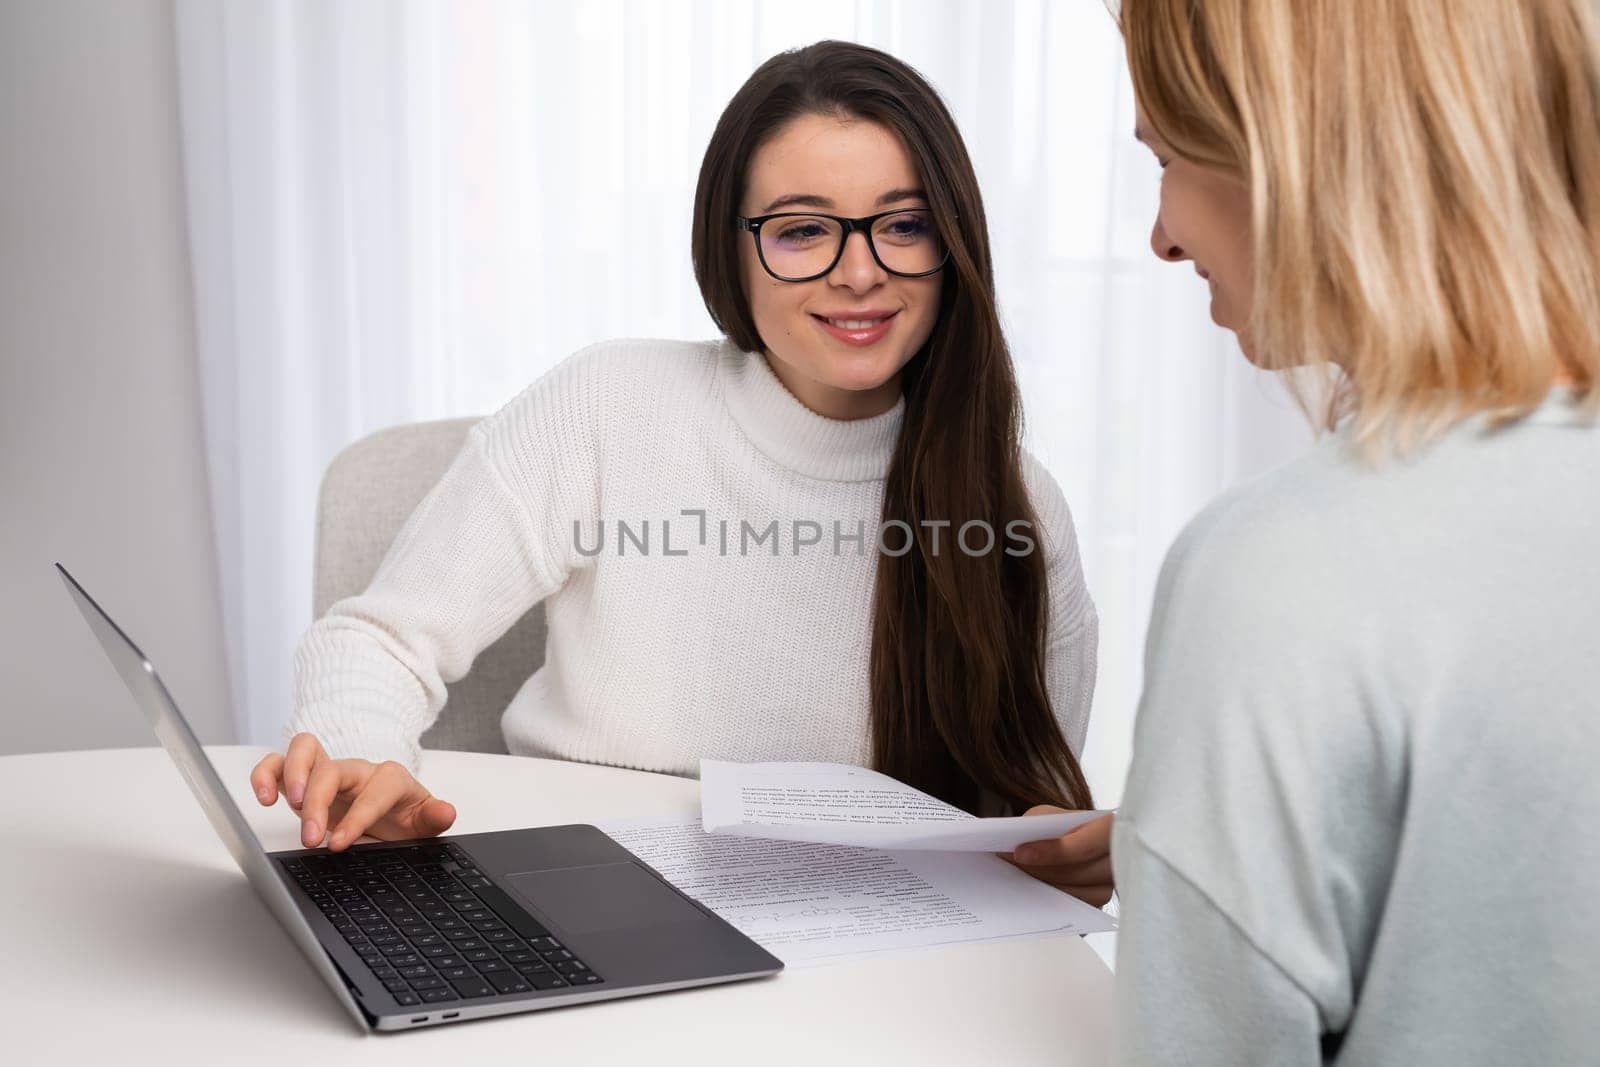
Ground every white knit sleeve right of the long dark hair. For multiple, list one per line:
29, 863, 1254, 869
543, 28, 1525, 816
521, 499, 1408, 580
1022, 453, 1099, 757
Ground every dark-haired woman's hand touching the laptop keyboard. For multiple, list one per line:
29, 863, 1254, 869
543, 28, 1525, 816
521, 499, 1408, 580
250, 734, 456, 851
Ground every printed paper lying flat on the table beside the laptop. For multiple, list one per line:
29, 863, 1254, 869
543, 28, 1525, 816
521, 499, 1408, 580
600, 819, 1115, 965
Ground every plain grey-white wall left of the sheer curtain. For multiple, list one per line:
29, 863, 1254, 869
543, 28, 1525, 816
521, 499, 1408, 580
0, 0, 233, 753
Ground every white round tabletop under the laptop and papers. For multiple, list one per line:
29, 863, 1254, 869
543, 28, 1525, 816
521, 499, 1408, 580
0, 747, 1112, 1067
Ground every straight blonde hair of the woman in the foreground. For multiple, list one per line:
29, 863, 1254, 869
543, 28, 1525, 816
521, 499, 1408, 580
1122, 0, 1600, 451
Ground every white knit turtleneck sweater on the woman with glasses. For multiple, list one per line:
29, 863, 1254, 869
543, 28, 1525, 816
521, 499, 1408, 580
285, 341, 1096, 776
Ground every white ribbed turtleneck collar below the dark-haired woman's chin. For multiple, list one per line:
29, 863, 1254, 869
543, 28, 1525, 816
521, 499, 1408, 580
717, 342, 906, 482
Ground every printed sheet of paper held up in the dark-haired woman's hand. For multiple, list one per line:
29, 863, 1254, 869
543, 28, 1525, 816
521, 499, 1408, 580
701, 760, 1110, 853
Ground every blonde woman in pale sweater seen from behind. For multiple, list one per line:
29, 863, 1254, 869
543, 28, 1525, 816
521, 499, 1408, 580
1112, 0, 1600, 1067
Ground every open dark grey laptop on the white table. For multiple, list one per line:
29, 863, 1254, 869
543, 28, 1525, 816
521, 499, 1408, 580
56, 563, 784, 1030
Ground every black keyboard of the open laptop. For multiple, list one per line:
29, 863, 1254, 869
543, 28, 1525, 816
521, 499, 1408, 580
282, 843, 603, 1005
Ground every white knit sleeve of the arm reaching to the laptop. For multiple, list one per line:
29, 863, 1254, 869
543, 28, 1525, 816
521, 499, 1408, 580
285, 354, 597, 769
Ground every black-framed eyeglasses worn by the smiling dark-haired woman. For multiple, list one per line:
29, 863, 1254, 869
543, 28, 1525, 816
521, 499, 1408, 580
736, 208, 950, 282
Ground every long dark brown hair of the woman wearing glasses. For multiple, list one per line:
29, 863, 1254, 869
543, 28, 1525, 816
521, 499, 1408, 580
693, 42, 1093, 813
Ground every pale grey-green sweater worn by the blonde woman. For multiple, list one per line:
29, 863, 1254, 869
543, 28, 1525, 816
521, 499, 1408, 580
1114, 394, 1600, 1067
